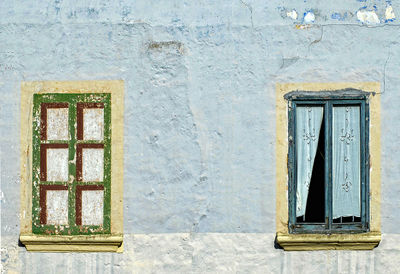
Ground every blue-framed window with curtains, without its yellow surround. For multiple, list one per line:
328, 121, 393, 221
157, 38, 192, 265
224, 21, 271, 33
286, 90, 369, 233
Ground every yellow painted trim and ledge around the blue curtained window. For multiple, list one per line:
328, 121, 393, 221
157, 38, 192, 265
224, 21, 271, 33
276, 82, 381, 250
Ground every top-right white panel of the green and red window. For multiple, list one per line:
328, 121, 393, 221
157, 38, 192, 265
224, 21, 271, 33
83, 108, 104, 140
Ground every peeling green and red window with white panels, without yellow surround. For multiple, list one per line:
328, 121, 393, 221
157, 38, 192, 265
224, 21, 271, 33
32, 93, 111, 235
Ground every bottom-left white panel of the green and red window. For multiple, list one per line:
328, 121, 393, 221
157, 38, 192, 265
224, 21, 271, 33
46, 190, 68, 225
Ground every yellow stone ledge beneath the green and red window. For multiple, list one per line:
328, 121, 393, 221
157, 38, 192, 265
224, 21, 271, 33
19, 234, 123, 252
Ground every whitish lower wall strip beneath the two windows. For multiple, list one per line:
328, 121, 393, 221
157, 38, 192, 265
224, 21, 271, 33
2, 233, 400, 274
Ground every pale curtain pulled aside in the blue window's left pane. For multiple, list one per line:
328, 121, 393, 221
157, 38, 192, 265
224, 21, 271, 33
296, 106, 324, 217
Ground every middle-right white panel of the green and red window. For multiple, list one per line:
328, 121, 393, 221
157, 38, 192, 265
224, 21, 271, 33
82, 148, 104, 182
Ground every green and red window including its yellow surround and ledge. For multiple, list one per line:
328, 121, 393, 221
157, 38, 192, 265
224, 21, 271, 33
20, 81, 123, 251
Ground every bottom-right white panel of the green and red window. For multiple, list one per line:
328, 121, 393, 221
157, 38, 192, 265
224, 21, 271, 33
82, 190, 104, 225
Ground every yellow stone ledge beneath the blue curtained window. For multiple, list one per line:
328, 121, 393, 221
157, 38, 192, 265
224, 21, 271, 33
276, 232, 381, 251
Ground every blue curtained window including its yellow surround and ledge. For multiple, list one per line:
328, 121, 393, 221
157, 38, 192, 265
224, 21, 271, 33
276, 83, 381, 250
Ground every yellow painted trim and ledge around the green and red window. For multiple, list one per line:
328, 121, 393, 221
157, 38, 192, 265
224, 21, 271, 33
20, 80, 124, 252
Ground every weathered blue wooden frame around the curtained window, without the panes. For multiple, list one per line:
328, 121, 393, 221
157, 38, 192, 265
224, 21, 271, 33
287, 96, 369, 234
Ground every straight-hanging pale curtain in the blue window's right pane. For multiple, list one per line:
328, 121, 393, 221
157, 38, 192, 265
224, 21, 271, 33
332, 106, 360, 219
